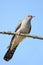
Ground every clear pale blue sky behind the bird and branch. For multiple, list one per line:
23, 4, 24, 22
0, 0, 43, 65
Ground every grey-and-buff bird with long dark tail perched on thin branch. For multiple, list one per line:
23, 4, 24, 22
4, 15, 35, 61
